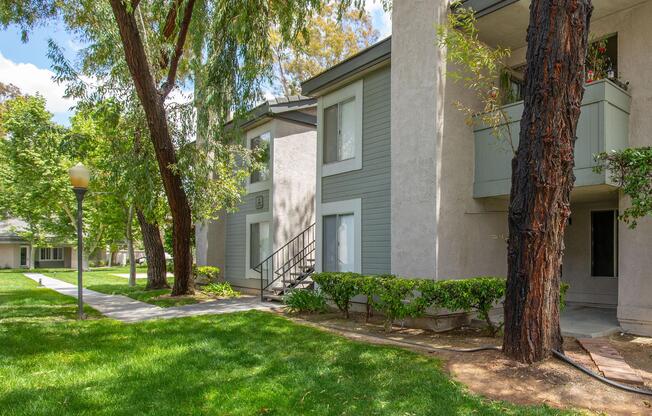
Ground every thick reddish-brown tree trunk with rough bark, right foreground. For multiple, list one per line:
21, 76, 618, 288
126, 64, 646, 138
503, 0, 593, 363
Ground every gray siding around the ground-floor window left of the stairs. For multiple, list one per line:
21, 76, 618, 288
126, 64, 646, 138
224, 191, 269, 280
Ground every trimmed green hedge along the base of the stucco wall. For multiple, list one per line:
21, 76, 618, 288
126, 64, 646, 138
312, 273, 569, 336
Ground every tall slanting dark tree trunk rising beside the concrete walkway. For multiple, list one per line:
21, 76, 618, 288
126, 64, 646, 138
111, 0, 194, 296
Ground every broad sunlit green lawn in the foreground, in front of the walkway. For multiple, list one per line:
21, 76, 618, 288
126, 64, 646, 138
0, 273, 573, 415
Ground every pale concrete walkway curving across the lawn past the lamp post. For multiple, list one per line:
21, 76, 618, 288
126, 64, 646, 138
25, 273, 278, 322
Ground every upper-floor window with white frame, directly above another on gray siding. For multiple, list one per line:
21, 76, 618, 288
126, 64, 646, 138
317, 80, 363, 176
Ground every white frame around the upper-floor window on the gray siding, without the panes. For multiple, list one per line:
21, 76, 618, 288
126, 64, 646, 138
317, 79, 363, 177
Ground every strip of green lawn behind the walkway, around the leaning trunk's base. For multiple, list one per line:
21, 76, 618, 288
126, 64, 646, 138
45, 267, 197, 308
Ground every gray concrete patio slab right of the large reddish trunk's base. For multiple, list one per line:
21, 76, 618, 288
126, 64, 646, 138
560, 305, 622, 338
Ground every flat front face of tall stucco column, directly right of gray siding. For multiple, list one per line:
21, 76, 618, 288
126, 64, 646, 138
390, 0, 446, 278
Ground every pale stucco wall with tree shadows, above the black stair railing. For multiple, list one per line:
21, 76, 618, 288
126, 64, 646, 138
271, 120, 317, 248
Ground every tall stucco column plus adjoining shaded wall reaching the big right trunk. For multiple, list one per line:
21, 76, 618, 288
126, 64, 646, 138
391, 0, 507, 279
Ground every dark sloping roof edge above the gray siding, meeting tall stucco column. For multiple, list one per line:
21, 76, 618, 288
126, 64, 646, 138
301, 36, 392, 95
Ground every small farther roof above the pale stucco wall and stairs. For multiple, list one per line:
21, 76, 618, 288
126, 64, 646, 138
234, 95, 317, 129
